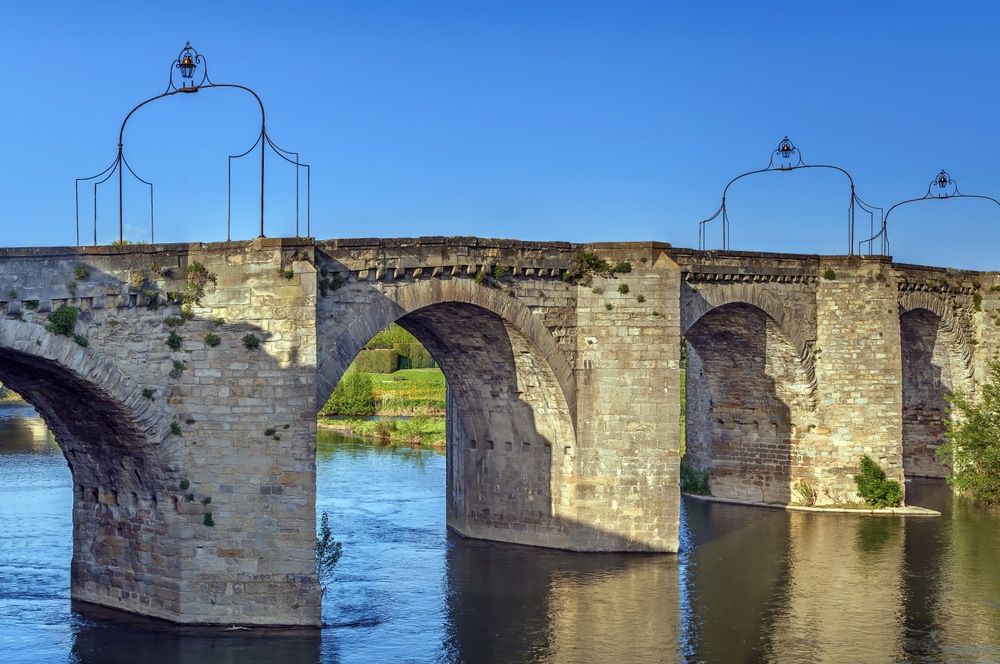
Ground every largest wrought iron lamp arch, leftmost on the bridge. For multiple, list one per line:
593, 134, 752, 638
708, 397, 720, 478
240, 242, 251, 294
76, 42, 312, 246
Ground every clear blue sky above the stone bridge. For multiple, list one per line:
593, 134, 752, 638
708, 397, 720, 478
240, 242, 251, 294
0, 0, 1000, 269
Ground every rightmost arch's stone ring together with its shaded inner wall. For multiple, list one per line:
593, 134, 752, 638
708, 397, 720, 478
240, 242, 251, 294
899, 292, 972, 477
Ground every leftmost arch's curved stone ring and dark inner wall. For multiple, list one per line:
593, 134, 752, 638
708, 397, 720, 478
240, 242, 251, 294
0, 320, 178, 617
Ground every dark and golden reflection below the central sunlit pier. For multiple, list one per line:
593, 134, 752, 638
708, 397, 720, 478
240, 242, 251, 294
446, 540, 681, 662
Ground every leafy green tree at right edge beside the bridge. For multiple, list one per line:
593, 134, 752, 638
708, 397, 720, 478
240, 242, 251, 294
935, 360, 1000, 506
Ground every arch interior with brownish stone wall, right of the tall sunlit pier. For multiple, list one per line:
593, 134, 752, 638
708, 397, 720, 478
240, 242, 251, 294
685, 303, 810, 503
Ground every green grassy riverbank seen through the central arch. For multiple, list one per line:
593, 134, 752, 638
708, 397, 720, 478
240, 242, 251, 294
318, 369, 445, 448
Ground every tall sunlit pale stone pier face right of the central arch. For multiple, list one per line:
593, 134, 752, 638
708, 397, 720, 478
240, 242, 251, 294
563, 245, 680, 551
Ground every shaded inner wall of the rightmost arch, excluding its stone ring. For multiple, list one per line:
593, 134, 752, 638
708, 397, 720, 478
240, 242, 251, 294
899, 309, 955, 477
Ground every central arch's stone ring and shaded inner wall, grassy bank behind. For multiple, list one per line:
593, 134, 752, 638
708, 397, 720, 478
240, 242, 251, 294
317, 279, 576, 548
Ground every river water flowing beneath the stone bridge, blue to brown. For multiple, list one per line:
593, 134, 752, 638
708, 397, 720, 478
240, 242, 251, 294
0, 406, 1000, 664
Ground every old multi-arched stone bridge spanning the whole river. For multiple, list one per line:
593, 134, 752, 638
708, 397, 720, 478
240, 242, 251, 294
0, 238, 1000, 626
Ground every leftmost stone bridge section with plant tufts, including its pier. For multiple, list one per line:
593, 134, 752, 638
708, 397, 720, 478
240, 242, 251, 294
0, 240, 319, 625
